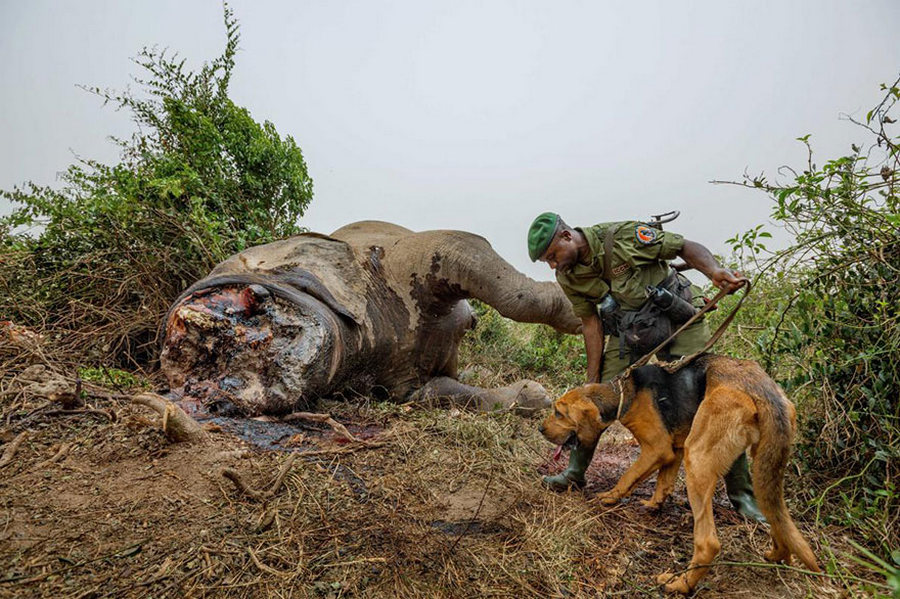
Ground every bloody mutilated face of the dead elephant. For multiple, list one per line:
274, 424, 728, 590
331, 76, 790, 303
161, 283, 345, 416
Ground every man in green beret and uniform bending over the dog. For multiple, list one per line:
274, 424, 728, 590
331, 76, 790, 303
528, 212, 765, 521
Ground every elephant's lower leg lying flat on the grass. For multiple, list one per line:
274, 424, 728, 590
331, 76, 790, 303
412, 376, 550, 415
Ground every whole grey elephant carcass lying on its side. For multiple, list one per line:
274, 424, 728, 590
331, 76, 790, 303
161, 221, 580, 415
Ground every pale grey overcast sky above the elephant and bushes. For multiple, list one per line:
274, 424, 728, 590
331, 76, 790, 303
0, 0, 900, 279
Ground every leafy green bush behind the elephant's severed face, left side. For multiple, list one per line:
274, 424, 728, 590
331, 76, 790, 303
0, 6, 312, 367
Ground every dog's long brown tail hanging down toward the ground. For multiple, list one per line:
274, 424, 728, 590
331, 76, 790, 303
752, 372, 820, 572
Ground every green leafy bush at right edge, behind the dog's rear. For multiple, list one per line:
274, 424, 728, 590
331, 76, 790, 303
731, 80, 900, 554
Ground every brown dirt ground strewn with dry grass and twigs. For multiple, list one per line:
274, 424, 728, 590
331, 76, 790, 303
0, 398, 884, 599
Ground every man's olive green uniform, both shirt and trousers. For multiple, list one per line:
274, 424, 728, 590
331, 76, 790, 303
556, 221, 710, 381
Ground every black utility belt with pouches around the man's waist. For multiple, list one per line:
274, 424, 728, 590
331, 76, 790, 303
597, 270, 698, 361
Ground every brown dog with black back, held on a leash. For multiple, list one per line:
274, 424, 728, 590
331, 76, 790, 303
539, 354, 820, 594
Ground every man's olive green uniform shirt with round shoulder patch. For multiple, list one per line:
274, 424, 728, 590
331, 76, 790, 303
556, 221, 684, 318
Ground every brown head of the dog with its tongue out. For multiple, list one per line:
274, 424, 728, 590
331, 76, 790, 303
538, 385, 612, 449
